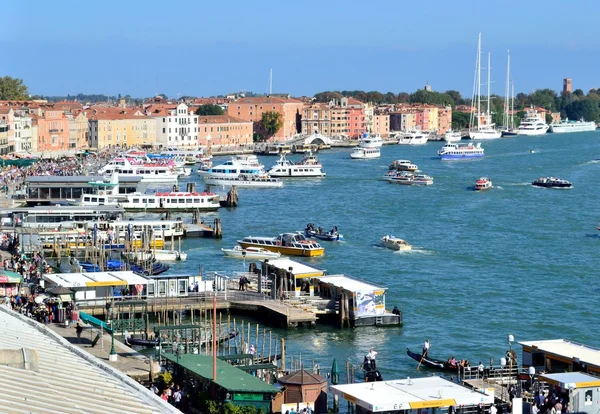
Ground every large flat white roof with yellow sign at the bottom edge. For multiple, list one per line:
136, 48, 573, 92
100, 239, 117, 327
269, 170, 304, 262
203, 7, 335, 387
331, 377, 494, 412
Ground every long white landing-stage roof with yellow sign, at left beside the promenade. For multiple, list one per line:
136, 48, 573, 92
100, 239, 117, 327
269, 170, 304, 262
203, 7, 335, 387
43, 271, 148, 288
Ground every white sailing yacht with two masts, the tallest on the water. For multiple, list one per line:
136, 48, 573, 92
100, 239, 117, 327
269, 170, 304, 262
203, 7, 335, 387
469, 33, 502, 140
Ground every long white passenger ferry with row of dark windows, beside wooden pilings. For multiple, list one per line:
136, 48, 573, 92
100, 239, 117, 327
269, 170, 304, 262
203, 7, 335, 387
119, 192, 221, 212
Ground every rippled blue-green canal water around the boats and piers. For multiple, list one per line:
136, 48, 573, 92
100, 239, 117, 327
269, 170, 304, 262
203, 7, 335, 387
157, 132, 600, 379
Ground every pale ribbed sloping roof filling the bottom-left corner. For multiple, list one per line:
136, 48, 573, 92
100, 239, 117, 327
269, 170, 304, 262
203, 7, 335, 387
0, 305, 180, 414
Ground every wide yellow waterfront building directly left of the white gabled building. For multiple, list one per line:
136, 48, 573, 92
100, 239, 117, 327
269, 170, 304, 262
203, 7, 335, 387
88, 111, 156, 149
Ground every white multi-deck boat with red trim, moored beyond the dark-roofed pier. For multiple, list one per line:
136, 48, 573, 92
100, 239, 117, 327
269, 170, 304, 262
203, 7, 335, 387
98, 157, 178, 184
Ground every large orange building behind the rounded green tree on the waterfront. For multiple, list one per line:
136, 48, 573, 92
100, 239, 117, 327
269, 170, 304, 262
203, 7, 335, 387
227, 96, 304, 141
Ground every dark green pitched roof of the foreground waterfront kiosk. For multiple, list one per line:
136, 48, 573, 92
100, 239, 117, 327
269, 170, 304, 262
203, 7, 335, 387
162, 354, 279, 394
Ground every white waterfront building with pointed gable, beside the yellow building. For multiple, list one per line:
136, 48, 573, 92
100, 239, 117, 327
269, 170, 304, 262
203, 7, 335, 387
148, 103, 198, 149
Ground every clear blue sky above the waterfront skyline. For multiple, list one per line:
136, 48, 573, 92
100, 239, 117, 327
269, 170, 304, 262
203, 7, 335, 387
0, 0, 600, 97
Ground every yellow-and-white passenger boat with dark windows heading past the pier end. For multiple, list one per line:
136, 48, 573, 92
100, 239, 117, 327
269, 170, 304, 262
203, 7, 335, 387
237, 233, 325, 257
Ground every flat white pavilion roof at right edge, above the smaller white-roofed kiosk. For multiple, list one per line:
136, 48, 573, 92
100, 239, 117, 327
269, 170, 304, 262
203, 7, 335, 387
519, 339, 600, 367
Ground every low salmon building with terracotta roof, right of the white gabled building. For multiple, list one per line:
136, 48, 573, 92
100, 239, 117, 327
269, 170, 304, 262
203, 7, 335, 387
197, 115, 253, 147
